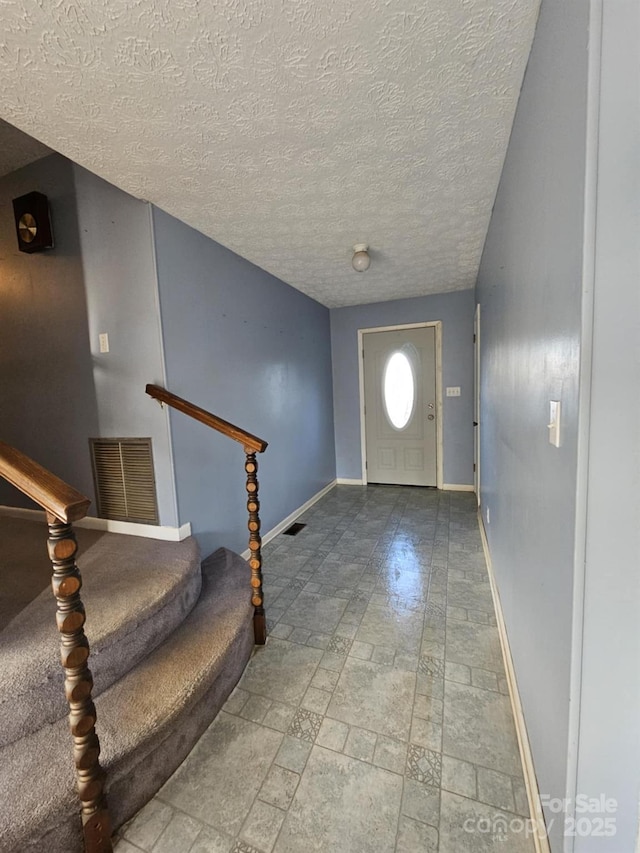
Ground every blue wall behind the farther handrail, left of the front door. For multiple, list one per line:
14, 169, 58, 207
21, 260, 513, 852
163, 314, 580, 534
153, 208, 335, 554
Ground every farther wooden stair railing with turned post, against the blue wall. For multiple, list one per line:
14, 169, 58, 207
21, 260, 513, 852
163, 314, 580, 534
145, 385, 267, 645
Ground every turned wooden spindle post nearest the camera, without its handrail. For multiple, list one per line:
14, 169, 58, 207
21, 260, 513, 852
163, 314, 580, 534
47, 513, 113, 853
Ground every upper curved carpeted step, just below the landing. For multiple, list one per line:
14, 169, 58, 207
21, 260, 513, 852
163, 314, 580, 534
0, 533, 201, 747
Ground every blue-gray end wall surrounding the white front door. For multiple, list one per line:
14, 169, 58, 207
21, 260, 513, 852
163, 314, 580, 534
331, 290, 475, 485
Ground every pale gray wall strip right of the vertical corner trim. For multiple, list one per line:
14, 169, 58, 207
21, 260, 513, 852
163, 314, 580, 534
575, 0, 640, 853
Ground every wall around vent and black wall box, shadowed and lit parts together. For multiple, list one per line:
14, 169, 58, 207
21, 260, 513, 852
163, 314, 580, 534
0, 154, 177, 525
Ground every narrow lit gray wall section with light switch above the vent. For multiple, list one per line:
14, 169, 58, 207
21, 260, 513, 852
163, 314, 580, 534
74, 166, 177, 526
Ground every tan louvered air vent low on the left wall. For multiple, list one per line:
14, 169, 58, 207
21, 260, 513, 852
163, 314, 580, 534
89, 438, 158, 524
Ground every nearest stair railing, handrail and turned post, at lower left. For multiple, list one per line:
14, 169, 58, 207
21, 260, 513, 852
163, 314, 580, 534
0, 441, 113, 853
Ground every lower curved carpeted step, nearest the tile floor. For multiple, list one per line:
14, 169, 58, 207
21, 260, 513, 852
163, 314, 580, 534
0, 548, 253, 853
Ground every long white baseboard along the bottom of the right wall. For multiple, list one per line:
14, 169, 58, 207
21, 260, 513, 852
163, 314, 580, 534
478, 512, 550, 853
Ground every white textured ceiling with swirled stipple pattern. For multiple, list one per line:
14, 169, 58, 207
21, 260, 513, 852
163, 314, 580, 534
0, 0, 539, 306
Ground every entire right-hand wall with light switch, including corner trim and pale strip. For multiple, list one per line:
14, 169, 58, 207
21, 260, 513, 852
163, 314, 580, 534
477, 0, 640, 853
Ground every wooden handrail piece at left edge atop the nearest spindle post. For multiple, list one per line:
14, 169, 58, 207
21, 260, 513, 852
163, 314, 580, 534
0, 441, 91, 524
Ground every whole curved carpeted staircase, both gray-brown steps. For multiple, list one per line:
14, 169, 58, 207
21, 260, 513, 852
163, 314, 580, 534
0, 534, 253, 853
